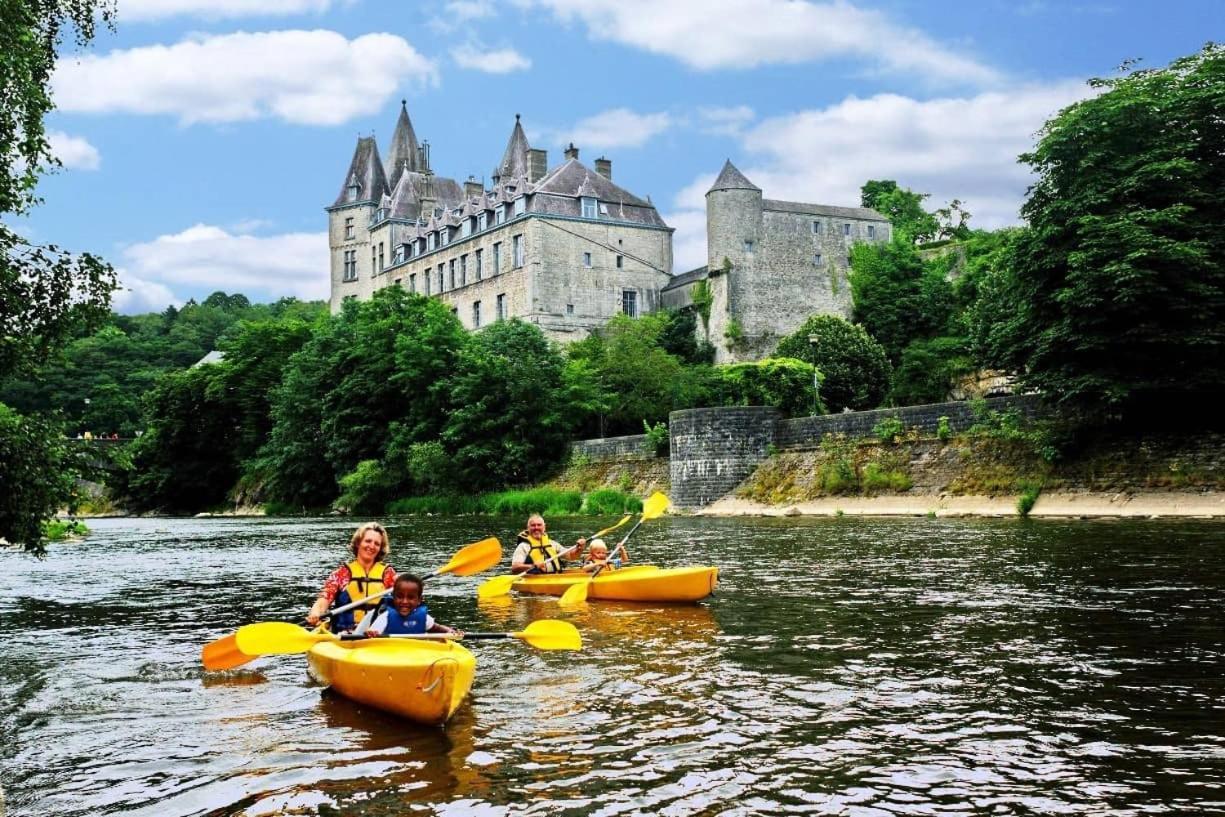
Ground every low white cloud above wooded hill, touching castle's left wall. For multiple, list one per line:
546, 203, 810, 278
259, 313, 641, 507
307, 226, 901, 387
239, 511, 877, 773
123, 224, 331, 306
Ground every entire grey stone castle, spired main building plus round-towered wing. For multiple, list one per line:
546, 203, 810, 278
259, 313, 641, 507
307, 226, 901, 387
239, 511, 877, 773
327, 102, 889, 363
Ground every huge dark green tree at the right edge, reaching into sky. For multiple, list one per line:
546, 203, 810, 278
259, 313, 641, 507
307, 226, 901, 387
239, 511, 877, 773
974, 44, 1225, 416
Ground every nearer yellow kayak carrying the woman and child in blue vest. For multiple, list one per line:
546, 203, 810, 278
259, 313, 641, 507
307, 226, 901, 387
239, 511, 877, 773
306, 638, 477, 725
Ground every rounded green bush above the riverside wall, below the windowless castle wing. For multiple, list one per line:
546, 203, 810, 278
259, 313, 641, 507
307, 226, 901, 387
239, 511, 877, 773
775, 315, 889, 412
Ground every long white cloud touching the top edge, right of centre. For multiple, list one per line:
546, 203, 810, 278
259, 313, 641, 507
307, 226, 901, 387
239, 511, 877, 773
518, 0, 1000, 85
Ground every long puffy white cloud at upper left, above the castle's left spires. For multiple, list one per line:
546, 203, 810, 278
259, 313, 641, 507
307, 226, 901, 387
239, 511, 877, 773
53, 31, 437, 125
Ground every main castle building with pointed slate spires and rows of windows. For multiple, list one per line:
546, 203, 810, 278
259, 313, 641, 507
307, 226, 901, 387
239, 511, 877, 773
327, 108, 673, 341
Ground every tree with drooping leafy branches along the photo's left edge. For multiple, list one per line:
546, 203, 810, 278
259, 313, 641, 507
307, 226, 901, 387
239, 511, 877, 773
0, 0, 116, 554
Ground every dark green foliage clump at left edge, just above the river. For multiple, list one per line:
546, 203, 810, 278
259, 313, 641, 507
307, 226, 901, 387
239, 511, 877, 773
0, 403, 87, 555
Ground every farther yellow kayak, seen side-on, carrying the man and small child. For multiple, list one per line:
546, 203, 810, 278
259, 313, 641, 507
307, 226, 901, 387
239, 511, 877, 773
511, 565, 719, 601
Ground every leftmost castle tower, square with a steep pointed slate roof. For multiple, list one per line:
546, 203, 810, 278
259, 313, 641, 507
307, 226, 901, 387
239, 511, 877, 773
327, 136, 390, 312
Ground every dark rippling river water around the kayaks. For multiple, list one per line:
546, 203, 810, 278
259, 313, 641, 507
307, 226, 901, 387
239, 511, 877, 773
0, 518, 1225, 817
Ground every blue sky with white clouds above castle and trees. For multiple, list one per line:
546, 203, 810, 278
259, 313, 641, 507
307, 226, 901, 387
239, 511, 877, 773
19, 0, 1225, 314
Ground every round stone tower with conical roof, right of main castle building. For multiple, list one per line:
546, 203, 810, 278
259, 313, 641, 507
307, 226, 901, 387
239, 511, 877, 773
706, 159, 764, 363
